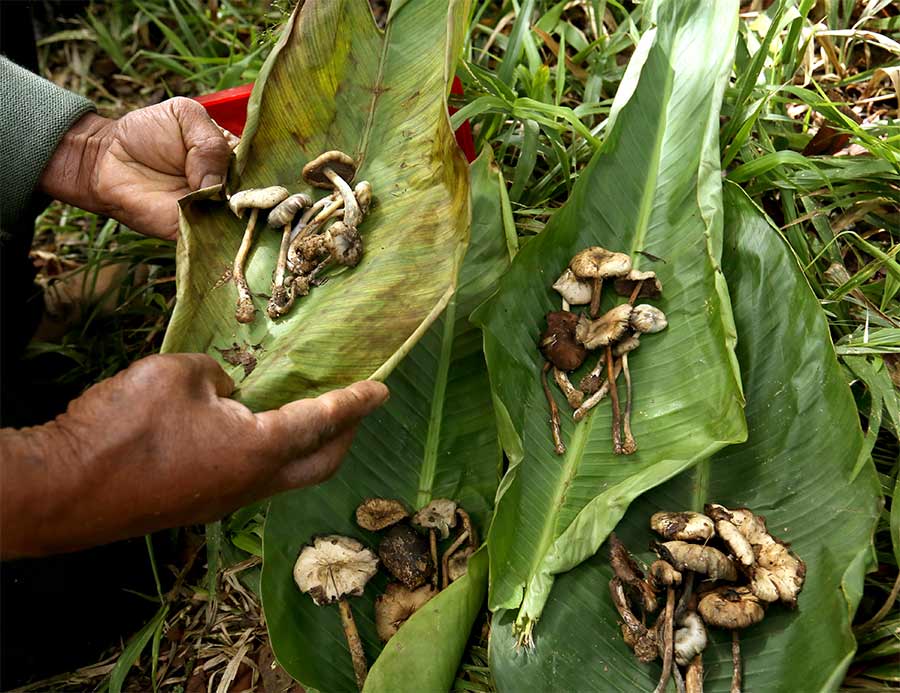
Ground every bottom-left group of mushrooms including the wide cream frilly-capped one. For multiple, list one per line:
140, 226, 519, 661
294, 498, 477, 690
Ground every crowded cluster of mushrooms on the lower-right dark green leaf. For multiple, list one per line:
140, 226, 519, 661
609, 503, 806, 693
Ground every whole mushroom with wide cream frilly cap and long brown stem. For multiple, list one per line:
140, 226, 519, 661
294, 535, 378, 690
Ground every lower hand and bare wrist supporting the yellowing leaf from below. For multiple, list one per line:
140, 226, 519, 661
0, 354, 388, 558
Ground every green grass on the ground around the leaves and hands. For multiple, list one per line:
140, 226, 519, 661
22, 0, 900, 691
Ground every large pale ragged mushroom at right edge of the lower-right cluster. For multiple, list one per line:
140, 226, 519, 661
704, 503, 806, 607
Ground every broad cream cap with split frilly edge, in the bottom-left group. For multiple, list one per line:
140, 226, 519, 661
294, 534, 378, 606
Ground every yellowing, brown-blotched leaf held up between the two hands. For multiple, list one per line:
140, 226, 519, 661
163, 0, 469, 409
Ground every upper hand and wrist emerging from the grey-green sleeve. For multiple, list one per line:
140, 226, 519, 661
40, 97, 233, 239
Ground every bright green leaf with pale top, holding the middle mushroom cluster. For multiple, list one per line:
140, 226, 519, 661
476, 0, 745, 630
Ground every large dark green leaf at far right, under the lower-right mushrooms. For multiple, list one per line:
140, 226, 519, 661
491, 185, 881, 693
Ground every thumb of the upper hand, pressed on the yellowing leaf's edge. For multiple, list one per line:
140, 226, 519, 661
172, 98, 231, 190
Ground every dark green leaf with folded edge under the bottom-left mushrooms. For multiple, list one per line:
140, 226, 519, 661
262, 150, 509, 693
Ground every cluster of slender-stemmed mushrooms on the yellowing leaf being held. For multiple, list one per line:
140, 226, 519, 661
228, 151, 372, 323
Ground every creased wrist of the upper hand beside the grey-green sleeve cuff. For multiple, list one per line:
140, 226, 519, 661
38, 113, 115, 213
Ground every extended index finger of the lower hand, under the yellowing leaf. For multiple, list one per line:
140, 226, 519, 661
257, 380, 388, 462
